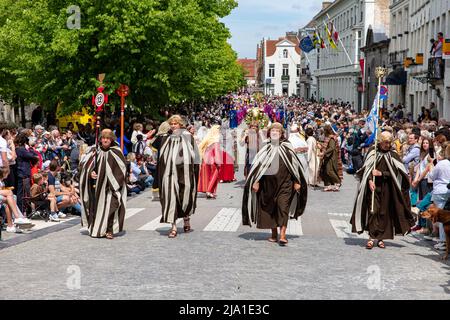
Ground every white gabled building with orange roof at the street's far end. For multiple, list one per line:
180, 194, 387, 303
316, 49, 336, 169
258, 32, 301, 96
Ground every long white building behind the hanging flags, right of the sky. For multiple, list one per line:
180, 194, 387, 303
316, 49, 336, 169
307, 0, 389, 110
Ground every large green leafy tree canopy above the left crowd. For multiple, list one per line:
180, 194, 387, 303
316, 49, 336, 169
0, 0, 244, 113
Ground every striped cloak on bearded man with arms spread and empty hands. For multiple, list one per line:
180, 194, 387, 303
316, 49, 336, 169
242, 141, 308, 226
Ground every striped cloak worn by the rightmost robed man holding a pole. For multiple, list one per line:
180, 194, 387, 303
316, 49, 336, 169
350, 147, 413, 234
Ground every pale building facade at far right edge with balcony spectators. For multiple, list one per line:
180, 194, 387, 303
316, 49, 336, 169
390, 0, 450, 119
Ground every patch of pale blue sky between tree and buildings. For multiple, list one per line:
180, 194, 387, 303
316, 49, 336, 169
221, 0, 323, 59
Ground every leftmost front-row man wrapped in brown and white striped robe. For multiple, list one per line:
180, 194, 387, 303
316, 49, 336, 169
80, 129, 127, 239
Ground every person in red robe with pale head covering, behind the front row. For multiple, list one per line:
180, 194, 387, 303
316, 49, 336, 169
197, 125, 223, 199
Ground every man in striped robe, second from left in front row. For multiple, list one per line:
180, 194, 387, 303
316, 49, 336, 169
158, 115, 200, 238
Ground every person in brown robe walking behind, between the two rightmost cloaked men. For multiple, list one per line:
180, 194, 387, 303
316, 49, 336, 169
320, 125, 343, 192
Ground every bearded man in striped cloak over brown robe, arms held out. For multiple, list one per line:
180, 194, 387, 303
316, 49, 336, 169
242, 123, 308, 245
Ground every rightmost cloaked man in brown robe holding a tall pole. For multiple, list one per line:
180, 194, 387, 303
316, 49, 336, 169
350, 131, 414, 249
